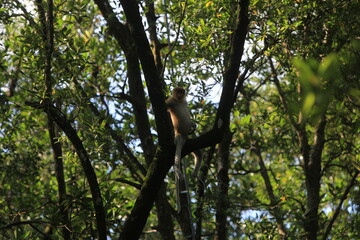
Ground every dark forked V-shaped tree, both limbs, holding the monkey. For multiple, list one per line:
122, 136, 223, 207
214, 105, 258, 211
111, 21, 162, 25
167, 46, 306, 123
91, 0, 249, 239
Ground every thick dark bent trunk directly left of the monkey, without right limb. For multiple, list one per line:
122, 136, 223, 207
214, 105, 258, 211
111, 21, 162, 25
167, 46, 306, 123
114, 0, 178, 240
